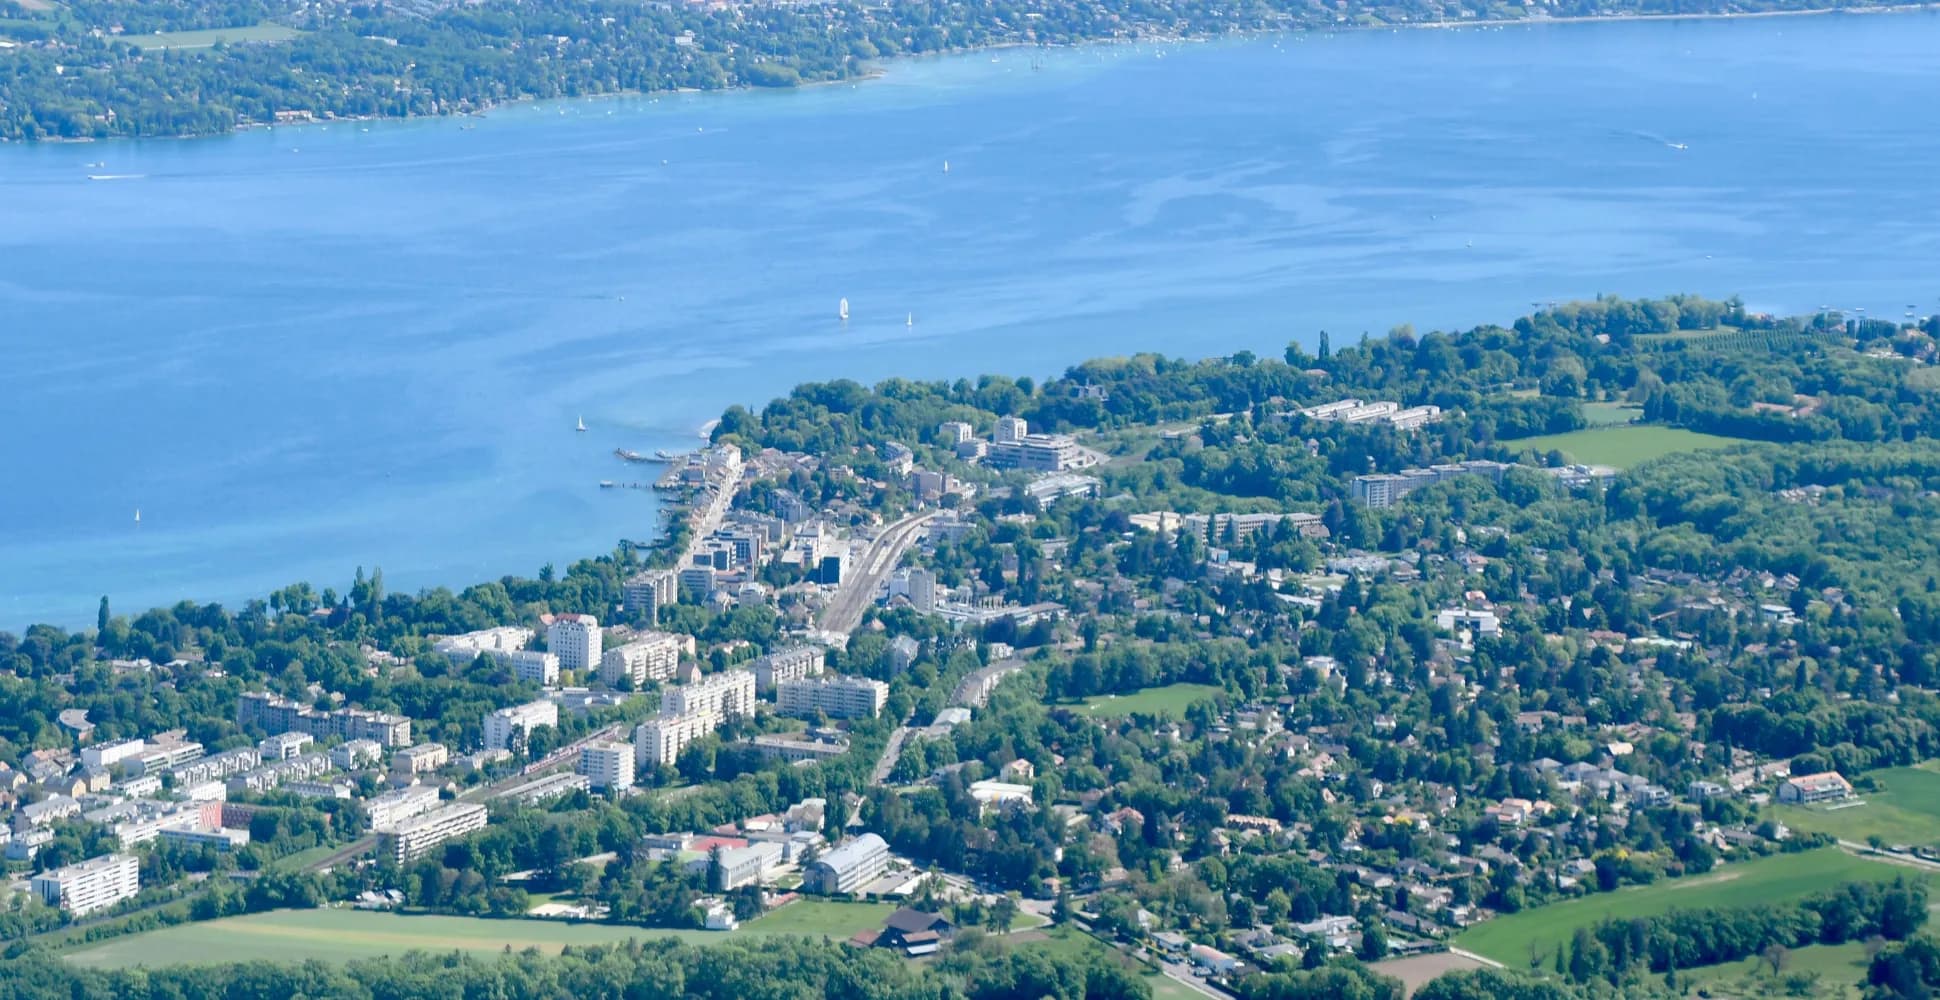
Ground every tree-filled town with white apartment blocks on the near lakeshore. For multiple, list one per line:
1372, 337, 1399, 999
0, 297, 1940, 1000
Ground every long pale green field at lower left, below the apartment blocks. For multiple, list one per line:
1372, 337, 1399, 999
66, 899, 894, 969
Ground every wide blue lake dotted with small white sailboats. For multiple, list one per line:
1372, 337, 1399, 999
0, 14, 1940, 629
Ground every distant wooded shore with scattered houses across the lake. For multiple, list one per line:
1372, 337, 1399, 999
0, 0, 1936, 142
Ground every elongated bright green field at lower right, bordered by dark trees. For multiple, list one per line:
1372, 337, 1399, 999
1455, 847, 1917, 969
